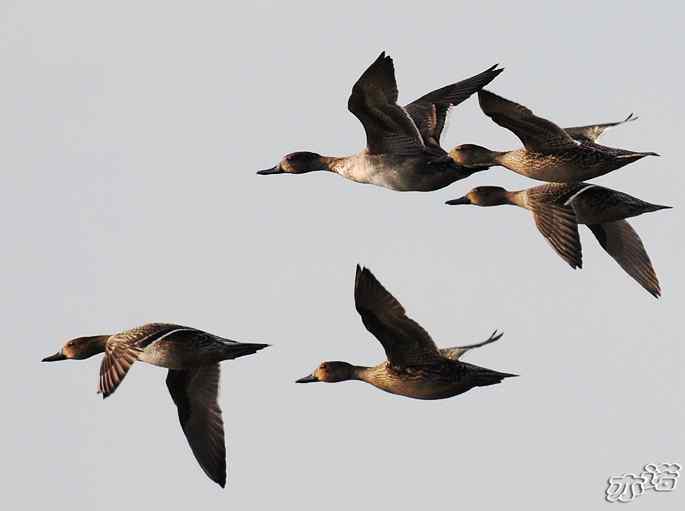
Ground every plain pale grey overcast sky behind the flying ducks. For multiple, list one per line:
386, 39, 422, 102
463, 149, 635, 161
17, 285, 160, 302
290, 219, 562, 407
0, 0, 685, 511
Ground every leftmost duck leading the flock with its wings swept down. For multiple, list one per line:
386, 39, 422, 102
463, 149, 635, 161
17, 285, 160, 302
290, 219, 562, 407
43, 323, 268, 487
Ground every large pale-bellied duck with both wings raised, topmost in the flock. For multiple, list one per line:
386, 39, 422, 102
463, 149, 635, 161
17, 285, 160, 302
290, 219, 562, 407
258, 52, 502, 191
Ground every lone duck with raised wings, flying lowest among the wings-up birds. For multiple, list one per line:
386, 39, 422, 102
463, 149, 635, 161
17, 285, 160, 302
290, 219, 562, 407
297, 266, 516, 400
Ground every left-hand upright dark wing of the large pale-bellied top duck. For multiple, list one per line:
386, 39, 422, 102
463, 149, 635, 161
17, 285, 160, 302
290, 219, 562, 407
347, 52, 424, 156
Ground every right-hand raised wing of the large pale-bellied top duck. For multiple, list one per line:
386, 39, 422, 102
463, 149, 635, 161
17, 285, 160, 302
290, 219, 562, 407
404, 64, 504, 146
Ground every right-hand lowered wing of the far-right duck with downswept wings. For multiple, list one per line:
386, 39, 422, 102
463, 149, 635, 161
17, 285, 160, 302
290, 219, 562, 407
588, 220, 661, 298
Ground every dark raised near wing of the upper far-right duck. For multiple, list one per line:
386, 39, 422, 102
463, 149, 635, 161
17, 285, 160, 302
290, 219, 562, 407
478, 90, 579, 153
